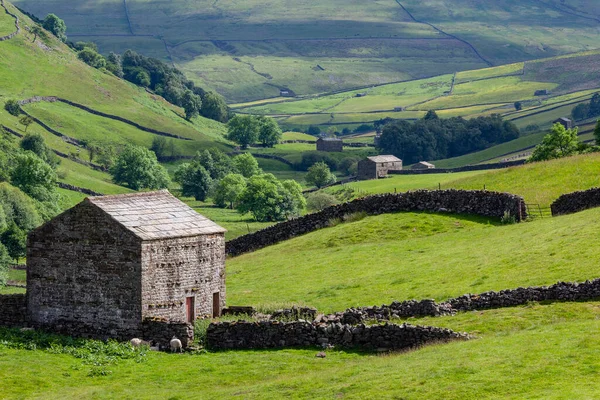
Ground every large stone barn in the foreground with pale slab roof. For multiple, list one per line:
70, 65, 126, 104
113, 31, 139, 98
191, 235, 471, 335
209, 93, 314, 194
27, 190, 225, 339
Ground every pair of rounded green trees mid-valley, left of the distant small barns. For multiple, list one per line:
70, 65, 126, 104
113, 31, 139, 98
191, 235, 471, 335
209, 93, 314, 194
227, 114, 282, 149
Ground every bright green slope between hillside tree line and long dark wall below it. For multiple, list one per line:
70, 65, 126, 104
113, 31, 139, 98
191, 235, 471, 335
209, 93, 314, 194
0, 15, 225, 146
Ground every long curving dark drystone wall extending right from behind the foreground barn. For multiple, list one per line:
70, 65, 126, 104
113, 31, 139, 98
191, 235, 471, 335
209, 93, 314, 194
226, 189, 527, 256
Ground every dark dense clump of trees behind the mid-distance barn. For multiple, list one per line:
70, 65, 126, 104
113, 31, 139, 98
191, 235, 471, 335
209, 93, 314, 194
378, 111, 519, 164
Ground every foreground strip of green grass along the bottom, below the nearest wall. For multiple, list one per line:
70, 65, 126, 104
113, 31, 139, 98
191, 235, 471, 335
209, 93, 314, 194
0, 302, 600, 400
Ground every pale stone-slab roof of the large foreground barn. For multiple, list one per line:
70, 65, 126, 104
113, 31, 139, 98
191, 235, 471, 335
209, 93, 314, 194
85, 190, 226, 240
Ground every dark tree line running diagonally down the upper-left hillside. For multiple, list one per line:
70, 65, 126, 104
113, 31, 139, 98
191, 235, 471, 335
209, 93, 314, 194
20, 14, 229, 122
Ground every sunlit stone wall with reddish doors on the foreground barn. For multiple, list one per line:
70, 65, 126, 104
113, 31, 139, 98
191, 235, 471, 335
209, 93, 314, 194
142, 234, 225, 322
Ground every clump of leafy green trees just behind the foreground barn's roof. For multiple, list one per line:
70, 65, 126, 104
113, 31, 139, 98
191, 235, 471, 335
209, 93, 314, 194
175, 149, 306, 221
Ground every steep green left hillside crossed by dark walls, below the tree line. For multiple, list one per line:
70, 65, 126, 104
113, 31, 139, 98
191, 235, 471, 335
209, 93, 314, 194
0, 2, 231, 200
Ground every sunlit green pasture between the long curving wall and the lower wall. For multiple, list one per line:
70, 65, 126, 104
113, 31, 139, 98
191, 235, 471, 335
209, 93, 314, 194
227, 206, 600, 312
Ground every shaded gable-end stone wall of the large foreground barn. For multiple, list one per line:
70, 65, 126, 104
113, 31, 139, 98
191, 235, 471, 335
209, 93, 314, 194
27, 202, 142, 338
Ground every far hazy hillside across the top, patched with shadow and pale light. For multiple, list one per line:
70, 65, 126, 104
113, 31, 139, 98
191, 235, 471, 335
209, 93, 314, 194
15, 0, 597, 102
